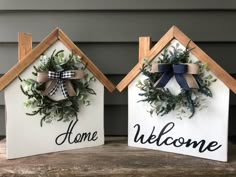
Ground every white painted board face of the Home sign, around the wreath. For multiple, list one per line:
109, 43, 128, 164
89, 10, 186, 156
5, 41, 104, 159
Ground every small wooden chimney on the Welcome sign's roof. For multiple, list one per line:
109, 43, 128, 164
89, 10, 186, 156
139, 36, 151, 62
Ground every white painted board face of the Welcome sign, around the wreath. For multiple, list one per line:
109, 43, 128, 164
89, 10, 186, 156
128, 39, 229, 161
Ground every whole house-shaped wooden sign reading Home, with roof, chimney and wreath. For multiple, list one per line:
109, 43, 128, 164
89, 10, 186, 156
0, 28, 115, 159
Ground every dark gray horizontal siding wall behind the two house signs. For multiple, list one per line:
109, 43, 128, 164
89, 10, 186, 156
0, 0, 236, 136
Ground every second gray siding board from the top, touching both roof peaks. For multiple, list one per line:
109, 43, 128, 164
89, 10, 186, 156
0, 11, 236, 42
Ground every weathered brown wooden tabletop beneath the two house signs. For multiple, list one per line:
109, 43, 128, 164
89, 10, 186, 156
0, 137, 236, 177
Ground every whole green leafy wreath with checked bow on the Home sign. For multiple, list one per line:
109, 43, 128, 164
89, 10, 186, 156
19, 50, 96, 126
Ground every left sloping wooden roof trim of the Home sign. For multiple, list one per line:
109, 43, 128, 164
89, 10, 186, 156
0, 29, 58, 91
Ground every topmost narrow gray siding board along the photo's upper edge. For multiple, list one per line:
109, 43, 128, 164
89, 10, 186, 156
0, 0, 236, 11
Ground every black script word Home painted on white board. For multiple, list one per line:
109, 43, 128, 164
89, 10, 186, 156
55, 119, 98, 145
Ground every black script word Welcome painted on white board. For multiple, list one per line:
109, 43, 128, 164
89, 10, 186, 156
134, 122, 222, 153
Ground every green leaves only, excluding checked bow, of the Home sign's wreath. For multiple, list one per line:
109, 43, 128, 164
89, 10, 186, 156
19, 50, 96, 126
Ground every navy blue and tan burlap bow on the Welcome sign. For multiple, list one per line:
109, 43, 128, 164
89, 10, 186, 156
151, 63, 199, 90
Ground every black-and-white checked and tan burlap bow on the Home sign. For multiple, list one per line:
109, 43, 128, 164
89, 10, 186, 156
37, 70, 84, 98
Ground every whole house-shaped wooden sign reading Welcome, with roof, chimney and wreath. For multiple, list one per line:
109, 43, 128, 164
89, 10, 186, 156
117, 26, 236, 161
